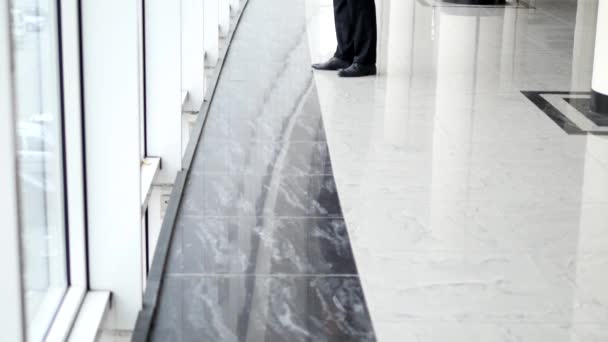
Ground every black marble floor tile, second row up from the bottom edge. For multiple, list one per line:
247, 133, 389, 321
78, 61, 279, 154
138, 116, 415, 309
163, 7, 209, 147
167, 216, 357, 275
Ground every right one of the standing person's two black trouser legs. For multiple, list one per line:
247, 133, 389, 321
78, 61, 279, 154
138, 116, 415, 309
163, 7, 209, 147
348, 0, 378, 64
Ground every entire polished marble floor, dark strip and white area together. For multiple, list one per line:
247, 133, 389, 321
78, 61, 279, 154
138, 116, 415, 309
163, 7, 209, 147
152, 0, 608, 342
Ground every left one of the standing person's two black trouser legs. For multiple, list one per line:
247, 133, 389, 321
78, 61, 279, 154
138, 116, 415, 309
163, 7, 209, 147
334, 0, 355, 62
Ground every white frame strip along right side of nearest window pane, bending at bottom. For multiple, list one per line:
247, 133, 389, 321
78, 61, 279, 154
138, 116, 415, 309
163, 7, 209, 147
47, 0, 88, 341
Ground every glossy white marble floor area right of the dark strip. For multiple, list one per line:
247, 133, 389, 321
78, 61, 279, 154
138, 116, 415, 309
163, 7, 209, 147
307, 0, 608, 342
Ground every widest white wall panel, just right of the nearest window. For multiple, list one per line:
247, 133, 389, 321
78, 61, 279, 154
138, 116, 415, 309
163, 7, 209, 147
82, 0, 143, 329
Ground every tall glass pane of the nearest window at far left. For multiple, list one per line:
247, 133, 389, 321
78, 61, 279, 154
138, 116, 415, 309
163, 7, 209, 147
11, 0, 68, 341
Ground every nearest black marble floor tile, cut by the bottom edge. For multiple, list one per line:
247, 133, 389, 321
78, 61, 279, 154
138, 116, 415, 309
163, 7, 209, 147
152, 276, 375, 342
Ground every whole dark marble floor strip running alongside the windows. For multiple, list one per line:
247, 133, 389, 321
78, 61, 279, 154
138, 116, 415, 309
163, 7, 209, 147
151, 0, 376, 342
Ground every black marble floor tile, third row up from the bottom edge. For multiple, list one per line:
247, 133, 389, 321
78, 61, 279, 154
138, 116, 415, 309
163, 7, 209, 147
180, 174, 342, 217
